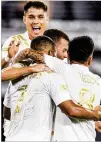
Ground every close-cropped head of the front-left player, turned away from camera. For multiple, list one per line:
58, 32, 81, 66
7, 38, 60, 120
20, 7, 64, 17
31, 36, 56, 56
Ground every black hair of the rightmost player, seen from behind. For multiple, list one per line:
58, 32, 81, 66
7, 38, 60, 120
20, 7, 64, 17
68, 36, 94, 63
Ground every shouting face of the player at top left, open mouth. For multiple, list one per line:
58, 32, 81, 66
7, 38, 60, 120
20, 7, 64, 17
23, 7, 48, 39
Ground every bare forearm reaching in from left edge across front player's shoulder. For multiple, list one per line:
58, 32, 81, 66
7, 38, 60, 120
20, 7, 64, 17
1, 67, 32, 81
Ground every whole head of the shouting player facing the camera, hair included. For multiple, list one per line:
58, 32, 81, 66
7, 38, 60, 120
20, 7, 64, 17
23, 1, 48, 40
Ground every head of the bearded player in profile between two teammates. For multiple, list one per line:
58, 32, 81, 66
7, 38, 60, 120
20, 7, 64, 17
44, 29, 69, 60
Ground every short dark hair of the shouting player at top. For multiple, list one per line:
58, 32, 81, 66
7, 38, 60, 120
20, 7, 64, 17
24, 1, 48, 12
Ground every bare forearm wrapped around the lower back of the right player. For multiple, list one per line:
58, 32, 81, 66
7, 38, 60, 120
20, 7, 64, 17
59, 100, 101, 120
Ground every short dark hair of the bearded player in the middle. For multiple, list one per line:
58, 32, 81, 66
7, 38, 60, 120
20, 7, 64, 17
44, 29, 69, 42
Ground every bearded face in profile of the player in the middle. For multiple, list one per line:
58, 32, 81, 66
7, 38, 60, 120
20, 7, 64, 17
56, 38, 69, 60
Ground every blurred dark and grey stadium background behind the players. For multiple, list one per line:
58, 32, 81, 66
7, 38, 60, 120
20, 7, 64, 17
1, 0, 101, 140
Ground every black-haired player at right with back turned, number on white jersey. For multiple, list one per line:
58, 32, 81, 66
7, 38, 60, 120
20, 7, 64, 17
45, 36, 101, 141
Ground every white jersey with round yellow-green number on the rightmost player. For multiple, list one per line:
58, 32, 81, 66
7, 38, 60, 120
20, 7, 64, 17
45, 55, 101, 141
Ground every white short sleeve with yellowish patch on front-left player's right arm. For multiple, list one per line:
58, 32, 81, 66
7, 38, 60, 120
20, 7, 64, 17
50, 73, 71, 106
